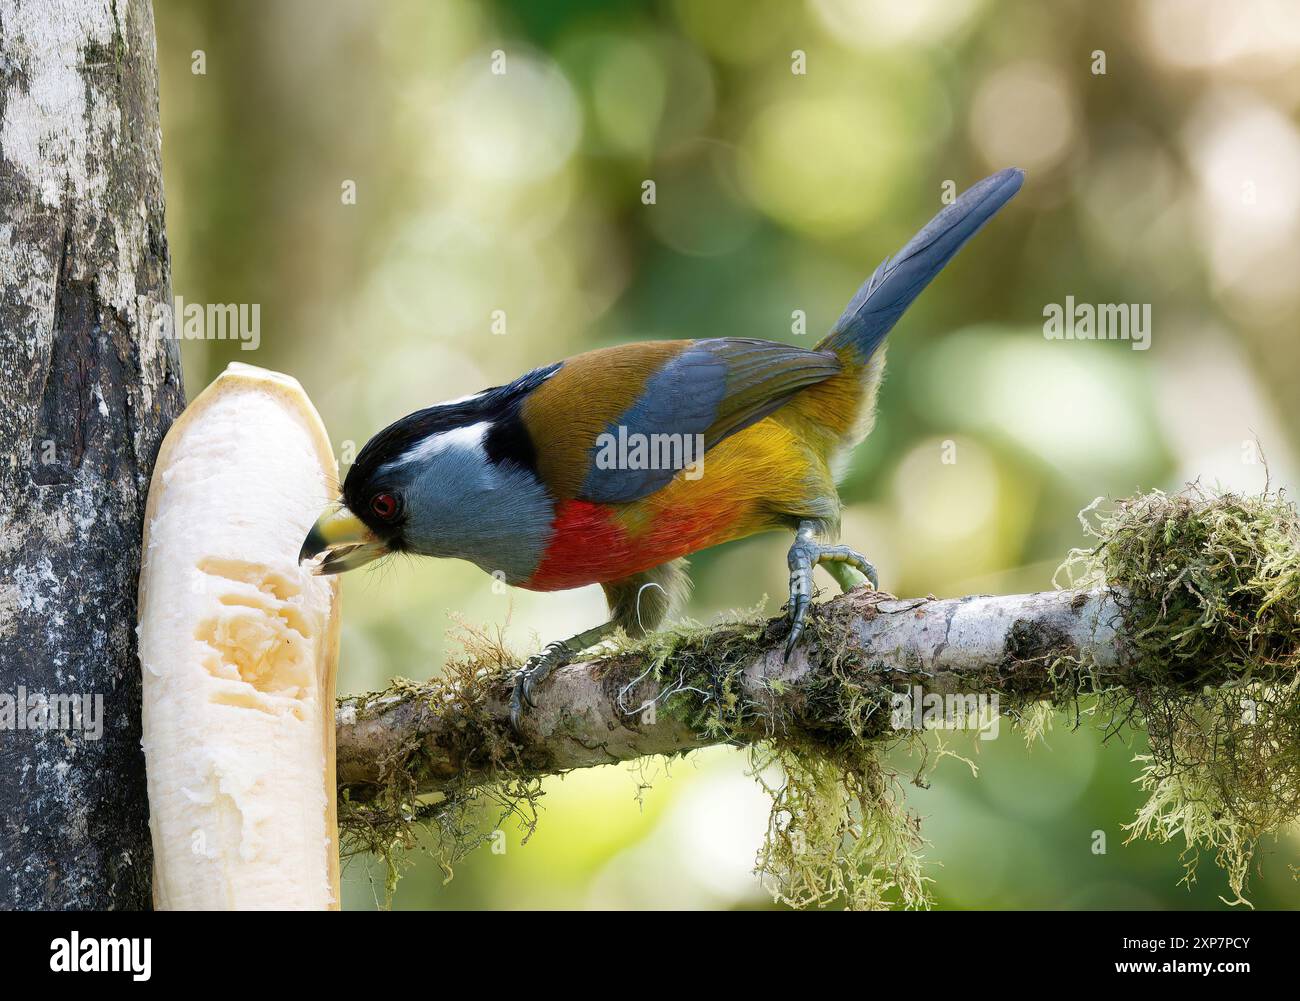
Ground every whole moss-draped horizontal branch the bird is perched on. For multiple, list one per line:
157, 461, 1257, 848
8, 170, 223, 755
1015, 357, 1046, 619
338, 486, 1300, 907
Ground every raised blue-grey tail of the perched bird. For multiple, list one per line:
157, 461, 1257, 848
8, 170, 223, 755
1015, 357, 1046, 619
818, 166, 1024, 361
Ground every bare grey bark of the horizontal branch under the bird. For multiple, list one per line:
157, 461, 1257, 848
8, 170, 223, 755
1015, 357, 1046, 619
335, 590, 1126, 801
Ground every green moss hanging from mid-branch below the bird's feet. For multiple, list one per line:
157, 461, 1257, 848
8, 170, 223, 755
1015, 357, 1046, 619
613, 600, 930, 910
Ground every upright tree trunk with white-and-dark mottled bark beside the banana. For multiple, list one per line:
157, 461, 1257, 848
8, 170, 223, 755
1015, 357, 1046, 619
0, 0, 183, 909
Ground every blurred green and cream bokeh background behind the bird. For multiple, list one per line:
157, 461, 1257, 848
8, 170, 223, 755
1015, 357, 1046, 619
155, 0, 1300, 909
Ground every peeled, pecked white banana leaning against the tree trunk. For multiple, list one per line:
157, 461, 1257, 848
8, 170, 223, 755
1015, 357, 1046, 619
139, 364, 339, 910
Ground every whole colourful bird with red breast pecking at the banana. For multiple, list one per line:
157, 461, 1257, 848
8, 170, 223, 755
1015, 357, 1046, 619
300, 168, 1024, 727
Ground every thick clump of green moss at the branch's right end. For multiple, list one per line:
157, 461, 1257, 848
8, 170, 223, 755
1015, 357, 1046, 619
1063, 486, 1300, 904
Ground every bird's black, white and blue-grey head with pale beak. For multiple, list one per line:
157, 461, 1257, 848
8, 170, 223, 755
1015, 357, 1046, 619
300, 365, 569, 584
